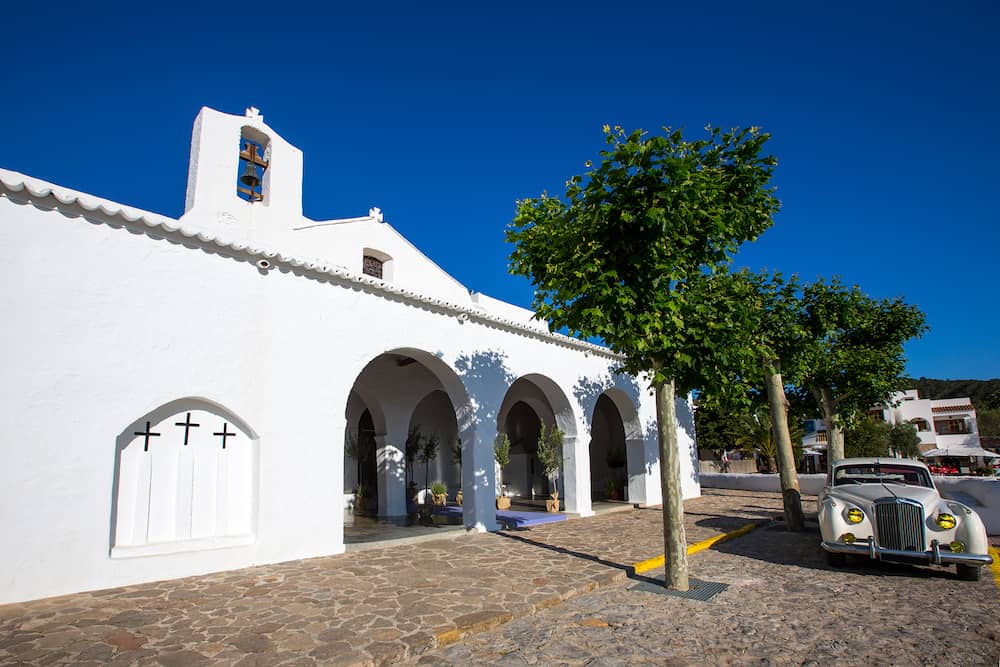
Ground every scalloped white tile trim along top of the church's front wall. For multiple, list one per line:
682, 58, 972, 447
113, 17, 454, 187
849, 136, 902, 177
0, 169, 622, 361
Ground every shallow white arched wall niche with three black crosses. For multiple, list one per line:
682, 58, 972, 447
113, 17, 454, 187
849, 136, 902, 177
111, 397, 259, 558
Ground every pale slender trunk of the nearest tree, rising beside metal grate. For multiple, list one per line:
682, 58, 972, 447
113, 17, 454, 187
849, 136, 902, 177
656, 380, 689, 591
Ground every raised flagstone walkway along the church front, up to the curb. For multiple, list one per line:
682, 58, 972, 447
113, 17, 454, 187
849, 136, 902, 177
0, 489, 796, 665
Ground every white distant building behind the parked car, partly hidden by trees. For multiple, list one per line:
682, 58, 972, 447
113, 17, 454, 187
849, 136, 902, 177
802, 389, 981, 452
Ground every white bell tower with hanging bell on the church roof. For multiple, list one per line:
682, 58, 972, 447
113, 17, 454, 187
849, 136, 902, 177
181, 107, 302, 242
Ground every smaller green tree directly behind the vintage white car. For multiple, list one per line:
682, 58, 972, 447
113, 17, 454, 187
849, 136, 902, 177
796, 279, 926, 466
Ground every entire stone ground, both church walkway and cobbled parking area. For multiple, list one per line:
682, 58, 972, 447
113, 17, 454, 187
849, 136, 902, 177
0, 489, 1000, 665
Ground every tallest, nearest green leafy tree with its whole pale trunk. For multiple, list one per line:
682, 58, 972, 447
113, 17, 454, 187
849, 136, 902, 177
507, 125, 779, 590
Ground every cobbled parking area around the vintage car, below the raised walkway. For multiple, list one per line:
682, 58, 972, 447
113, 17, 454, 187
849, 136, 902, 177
412, 526, 1000, 667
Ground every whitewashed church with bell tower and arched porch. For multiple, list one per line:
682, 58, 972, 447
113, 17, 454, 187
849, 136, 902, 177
0, 108, 700, 603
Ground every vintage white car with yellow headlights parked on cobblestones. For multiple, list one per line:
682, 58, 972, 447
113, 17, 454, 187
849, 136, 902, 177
817, 458, 993, 581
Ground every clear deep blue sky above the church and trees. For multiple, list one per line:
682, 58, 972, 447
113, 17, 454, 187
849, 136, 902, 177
0, 0, 1000, 379
